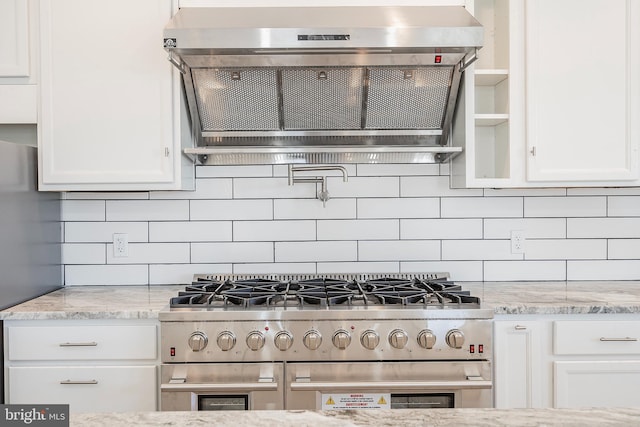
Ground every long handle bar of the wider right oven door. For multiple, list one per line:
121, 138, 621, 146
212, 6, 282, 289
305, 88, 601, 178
291, 380, 492, 391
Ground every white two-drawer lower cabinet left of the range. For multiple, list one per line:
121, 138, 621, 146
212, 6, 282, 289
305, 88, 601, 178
4, 319, 159, 412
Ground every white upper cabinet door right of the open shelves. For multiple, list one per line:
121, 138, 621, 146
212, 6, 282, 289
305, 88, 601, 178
525, 0, 640, 185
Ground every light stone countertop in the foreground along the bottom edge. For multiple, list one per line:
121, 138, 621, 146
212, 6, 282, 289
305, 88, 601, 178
70, 408, 640, 427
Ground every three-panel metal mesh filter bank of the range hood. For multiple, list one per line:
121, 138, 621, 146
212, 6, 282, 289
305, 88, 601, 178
192, 66, 454, 132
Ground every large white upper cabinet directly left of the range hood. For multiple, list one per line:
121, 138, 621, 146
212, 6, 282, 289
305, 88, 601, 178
38, 0, 193, 191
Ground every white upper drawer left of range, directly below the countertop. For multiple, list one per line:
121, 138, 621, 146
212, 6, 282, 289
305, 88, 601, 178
7, 325, 157, 360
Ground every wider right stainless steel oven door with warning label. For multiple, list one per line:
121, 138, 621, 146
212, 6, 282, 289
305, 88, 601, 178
285, 361, 493, 410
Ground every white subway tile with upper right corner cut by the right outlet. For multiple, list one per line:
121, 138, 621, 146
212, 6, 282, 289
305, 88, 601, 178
442, 240, 523, 261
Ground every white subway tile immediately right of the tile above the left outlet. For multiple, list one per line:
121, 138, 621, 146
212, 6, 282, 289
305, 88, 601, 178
149, 221, 232, 242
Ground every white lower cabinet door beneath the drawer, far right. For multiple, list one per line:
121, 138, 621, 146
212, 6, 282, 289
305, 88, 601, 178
554, 361, 640, 408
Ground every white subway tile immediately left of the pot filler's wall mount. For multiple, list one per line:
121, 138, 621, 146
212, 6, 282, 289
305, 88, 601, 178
233, 178, 317, 199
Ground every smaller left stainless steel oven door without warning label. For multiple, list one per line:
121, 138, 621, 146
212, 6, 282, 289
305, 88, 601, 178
160, 363, 284, 411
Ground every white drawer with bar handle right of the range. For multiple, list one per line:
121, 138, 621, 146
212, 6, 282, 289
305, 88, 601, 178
553, 320, 640, 355
